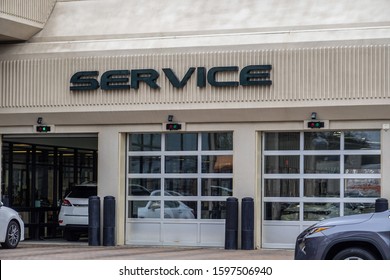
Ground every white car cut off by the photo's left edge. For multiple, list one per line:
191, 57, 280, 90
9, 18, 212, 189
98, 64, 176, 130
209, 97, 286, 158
0, 202, 24, 249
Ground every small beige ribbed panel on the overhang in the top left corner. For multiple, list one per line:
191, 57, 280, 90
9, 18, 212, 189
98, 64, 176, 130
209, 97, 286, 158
0, 0, 56, 24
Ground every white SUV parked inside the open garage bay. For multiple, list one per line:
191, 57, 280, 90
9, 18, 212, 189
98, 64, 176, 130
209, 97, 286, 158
58, 182, 97, 241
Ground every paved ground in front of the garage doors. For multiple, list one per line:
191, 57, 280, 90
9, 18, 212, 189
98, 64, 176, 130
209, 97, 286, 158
0, 240, 294, 260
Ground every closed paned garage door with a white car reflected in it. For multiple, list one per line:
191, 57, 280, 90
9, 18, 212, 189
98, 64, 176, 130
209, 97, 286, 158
126, 132, 233, 246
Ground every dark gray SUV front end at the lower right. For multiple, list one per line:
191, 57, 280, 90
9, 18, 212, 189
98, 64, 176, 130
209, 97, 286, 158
295, 210, 390, 260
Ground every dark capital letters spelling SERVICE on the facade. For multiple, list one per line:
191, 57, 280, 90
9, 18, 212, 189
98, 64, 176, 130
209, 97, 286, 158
70, 64, 272, 91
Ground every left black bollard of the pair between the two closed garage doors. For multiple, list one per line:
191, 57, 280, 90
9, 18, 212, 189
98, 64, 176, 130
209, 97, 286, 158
225, 197, 238, 250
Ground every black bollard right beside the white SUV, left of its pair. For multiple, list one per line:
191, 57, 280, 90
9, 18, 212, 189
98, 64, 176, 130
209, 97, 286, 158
88, 196, 100, 246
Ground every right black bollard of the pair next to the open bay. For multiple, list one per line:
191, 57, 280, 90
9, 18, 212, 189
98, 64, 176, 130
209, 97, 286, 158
103, 196, 115, 246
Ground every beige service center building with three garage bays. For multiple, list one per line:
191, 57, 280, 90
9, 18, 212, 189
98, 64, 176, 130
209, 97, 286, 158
0, 0, 390, 248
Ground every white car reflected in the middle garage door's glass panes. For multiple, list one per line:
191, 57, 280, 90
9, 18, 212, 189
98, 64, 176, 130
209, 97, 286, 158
138, 190, 195, 219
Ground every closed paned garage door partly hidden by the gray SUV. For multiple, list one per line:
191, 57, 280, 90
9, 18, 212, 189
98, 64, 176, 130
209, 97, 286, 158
261, 130, 381, 248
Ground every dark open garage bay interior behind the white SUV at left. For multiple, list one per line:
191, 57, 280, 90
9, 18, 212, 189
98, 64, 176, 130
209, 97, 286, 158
1, 140, 97, 239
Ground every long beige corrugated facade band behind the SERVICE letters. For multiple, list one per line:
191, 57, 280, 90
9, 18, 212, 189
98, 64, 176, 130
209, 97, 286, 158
0, 45, 390, 108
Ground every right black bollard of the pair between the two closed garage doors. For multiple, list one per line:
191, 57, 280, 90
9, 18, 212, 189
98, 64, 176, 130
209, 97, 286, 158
241, 197, 255, 250
